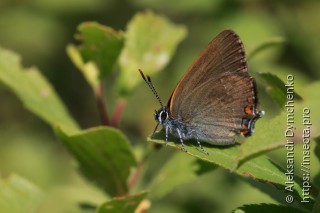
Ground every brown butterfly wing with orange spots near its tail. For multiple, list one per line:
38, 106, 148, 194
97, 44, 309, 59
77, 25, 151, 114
168, 30, 258, 144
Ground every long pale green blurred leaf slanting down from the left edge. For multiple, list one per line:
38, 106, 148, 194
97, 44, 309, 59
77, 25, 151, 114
0, 48, 79, 132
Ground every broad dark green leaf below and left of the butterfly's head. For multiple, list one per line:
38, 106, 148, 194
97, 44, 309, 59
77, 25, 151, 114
56, 127, 136, 196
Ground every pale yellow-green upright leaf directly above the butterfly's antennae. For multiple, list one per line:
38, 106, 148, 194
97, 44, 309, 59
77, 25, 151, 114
118, 11, 186, 95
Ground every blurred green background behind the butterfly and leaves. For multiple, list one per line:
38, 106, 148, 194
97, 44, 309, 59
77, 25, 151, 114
0, 0, 320, 212
